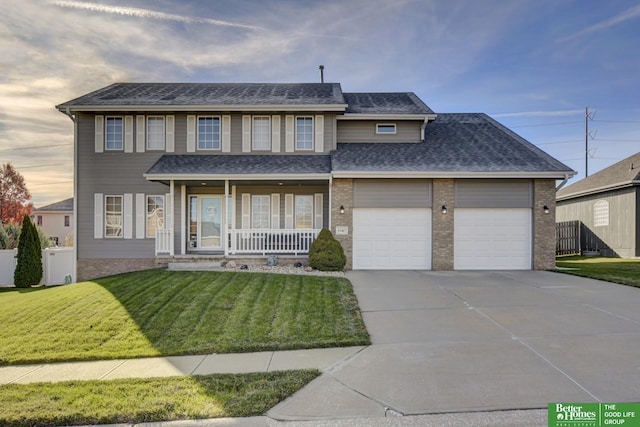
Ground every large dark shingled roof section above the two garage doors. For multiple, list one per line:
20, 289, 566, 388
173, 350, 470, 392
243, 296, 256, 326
332, 113, 576, 178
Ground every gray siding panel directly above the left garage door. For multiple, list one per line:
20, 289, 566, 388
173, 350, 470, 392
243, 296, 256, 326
353, 179, 432, 208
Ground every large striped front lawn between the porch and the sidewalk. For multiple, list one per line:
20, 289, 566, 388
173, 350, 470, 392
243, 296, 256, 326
0, 270, 370, 365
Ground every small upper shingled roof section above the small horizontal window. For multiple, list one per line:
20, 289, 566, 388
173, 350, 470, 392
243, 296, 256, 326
344, 92, 434, 114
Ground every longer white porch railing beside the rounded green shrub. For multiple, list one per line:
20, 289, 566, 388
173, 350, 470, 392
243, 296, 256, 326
229, 229, 320, 255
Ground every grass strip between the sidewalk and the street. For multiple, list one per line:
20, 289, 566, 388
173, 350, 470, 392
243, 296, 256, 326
0, 370, 319, 427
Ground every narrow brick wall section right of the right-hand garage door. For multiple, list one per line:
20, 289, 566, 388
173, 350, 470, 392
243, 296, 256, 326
533, 179, 556, 270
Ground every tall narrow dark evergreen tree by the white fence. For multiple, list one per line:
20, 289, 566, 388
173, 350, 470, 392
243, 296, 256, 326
13, 214, 42, 288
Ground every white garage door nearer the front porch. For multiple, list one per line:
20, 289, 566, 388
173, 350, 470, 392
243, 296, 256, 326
353, 208, 431, 270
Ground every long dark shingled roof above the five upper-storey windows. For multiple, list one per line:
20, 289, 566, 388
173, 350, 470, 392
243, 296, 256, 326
56, 83, 346, 111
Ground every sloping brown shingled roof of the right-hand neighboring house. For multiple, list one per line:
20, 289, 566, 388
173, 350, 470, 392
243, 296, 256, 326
556, 153, 640, 200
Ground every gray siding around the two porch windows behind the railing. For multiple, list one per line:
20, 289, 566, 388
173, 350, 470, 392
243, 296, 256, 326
235, 185, 329, 229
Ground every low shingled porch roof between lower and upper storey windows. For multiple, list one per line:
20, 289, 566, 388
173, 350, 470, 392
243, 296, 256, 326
144, 154, 331, 180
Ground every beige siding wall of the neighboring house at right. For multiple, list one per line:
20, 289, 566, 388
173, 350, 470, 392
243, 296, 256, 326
556, 187, 640, 258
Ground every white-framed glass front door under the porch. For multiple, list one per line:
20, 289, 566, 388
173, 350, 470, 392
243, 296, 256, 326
189, 196, 224, 250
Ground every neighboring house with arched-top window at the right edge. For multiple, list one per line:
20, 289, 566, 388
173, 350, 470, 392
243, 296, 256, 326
556, 153, 640, 258
